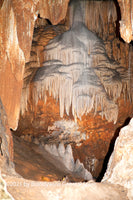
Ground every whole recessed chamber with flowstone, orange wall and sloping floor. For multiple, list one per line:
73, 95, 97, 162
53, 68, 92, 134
12, 1, 133, 182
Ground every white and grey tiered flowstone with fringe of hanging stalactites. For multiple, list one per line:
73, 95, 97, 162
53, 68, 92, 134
22, 0, 130, 123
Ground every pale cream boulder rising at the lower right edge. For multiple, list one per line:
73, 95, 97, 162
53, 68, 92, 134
103, 118, 133, 199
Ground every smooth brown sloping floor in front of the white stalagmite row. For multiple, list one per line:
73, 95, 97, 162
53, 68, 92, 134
13, 136, 83, 182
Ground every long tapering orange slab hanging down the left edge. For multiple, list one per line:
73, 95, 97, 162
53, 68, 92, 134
0, 1, 25, 128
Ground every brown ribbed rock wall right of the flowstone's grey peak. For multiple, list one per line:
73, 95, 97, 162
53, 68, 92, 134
82, 1, 129, 68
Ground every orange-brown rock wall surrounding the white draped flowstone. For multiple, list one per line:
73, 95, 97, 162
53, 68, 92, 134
16, 1, 132, 177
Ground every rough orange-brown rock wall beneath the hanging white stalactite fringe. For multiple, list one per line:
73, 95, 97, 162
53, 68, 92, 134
16, 89, 133, 177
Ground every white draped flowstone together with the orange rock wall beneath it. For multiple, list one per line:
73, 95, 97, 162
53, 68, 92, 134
17, 1, 132, 177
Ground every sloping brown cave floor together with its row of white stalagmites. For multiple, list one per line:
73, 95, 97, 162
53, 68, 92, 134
14, 137, 92, 182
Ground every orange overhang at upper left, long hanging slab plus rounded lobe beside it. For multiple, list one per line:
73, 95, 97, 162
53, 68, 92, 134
0, 0, 68, 129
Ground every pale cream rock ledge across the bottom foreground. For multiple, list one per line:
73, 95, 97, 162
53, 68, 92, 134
4, 176, 128, 200
